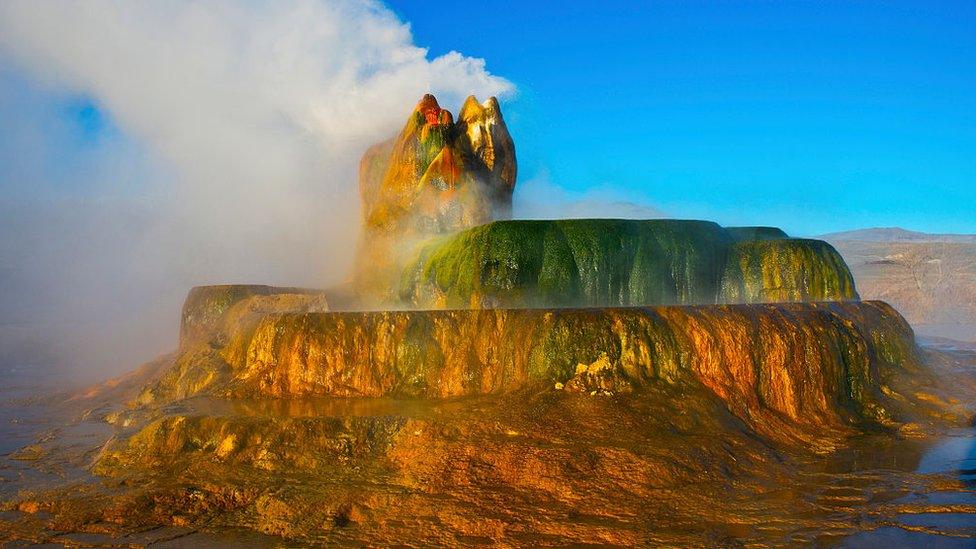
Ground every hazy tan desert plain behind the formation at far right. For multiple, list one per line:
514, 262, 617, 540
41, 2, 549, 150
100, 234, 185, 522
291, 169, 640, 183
829, 239, 976, 341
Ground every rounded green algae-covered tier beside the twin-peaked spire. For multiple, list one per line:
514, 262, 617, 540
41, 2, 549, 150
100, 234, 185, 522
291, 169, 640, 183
398, 219, 858, 309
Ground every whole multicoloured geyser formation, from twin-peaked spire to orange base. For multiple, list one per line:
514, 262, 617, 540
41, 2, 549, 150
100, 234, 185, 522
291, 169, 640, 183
11, 95, 974, 546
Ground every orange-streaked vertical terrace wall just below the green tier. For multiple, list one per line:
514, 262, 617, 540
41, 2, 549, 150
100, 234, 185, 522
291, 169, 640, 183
142, 302, 916, 444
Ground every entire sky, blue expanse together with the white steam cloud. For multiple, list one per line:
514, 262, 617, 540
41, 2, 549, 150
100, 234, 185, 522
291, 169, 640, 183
0, 0, 976, 371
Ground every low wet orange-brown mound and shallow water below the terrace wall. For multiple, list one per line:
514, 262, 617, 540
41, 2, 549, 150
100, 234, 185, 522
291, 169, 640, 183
0, 340, 976, 546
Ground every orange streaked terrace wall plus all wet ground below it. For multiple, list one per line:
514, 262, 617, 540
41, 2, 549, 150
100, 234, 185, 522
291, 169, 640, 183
0, 282, 976, 546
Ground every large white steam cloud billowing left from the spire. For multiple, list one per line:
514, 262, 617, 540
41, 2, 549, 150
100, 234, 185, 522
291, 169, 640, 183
0, 0, 514, 375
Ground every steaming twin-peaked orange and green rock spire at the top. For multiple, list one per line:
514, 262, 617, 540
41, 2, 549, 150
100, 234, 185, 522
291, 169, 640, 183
356, 95, 517, 301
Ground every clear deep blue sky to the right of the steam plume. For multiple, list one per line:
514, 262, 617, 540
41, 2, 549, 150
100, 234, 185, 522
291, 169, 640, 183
389, 0, 976, 234
